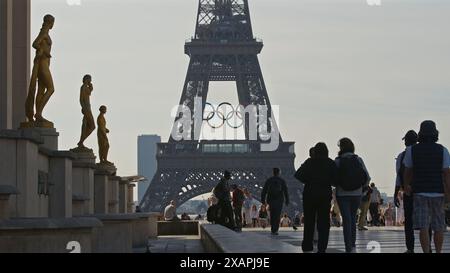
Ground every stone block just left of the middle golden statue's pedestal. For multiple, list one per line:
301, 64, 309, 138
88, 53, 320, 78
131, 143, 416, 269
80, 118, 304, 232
49, 151, 75, 218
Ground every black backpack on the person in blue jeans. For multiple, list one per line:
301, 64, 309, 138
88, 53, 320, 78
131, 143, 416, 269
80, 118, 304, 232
338, 155, 367, 191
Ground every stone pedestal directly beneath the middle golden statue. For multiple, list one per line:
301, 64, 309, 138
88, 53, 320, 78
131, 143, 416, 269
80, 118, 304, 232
71, 148, 95, 216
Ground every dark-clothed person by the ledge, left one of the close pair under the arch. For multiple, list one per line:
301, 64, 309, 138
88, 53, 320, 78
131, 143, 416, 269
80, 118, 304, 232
213, 171, 236, 230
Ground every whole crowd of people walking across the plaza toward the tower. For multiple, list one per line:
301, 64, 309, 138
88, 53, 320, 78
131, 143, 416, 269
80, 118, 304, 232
166, 121, 450, 253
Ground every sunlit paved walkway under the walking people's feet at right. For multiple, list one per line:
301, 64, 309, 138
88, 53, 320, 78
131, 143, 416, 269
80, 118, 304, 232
248, 227, 450, 253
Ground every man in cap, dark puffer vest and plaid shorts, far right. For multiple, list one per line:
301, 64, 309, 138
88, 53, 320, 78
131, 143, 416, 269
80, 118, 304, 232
403, 121, 450, 253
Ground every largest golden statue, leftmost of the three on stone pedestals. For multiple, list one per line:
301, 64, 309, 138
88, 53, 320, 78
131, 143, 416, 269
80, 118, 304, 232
22, 15, 55, 128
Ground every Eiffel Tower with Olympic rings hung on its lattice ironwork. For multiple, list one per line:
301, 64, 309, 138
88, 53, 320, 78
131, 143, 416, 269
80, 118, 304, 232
140, 0, 303, 216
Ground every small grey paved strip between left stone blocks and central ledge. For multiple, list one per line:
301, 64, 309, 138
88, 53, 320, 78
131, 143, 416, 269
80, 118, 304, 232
149, 236, 204, 253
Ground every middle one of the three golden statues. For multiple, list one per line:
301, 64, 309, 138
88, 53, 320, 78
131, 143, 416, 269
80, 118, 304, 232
78, 75, 95, 150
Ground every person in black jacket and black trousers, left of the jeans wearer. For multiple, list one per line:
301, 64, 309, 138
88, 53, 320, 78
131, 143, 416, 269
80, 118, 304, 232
295, 143, 337, 253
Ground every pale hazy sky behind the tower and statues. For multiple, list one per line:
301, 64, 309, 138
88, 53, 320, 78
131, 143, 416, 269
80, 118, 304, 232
32, 0, 450, 194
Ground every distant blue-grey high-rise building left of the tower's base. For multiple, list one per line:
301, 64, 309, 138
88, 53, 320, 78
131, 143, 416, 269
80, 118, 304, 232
138, 135, 161, 202
